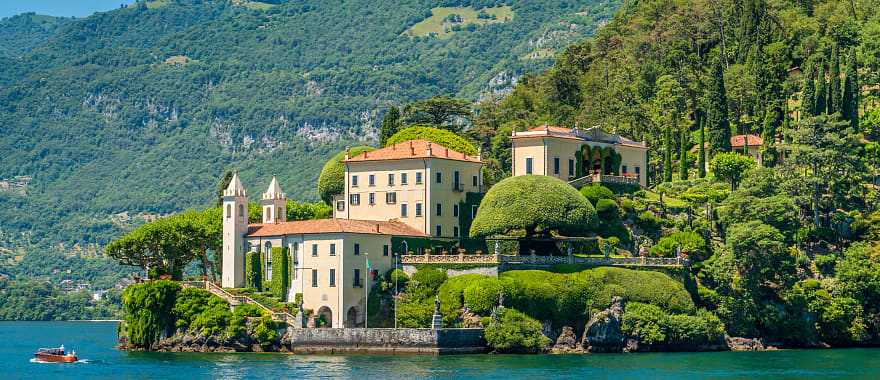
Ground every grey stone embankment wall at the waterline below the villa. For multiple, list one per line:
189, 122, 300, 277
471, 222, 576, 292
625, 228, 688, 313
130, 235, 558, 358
282, 328, 487, 354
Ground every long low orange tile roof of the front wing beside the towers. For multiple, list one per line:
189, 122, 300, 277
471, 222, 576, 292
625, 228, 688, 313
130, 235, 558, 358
247, 218, 426, 237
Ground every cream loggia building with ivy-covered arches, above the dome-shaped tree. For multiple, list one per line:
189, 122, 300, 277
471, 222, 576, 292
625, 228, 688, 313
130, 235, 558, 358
511, 125, 648, 186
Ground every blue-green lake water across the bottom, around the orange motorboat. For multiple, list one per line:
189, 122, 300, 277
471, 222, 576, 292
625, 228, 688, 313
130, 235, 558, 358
0, 322, 880, 380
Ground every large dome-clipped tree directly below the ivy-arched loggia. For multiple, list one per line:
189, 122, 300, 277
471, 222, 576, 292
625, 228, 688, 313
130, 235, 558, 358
471, 175, 597, 236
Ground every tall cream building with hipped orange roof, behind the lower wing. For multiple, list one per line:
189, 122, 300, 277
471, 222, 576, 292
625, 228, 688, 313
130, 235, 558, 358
334, 140, 484, 238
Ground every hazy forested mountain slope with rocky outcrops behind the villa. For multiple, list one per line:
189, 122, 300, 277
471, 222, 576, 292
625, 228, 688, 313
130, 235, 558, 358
0, 0, 619, 252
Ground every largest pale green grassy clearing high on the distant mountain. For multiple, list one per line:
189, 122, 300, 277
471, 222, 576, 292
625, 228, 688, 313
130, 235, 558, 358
405, 5, 514, 38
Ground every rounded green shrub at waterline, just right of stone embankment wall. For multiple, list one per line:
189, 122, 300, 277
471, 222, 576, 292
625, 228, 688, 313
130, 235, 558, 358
485, 308, 550, 353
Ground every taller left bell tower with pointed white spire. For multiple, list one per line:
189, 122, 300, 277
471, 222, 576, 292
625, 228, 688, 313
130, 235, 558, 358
221, 172, 248, 288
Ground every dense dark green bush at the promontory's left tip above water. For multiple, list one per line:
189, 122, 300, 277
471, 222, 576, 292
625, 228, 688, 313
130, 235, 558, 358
122, 280, 180, 349
